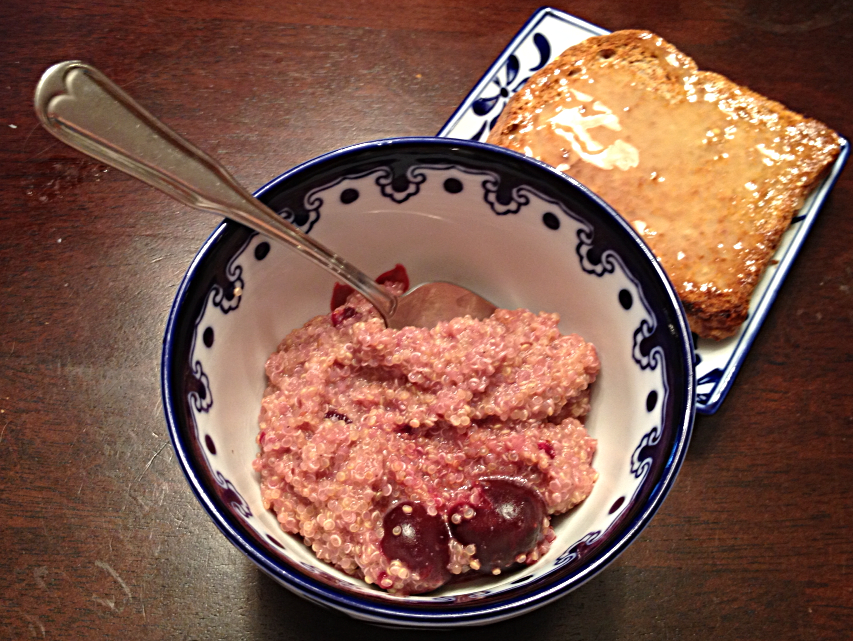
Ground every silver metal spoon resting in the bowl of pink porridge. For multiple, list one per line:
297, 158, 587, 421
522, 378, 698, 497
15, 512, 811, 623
35, 61, 495, 329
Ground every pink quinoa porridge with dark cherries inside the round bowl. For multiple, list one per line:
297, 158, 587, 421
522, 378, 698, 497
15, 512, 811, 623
253, 276, 599, 594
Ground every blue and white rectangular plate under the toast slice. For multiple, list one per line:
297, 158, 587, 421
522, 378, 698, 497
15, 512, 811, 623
438, 7, 850, 414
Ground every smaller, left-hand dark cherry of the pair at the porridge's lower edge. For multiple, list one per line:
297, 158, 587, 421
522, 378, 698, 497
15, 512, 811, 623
381, 501, 450, 592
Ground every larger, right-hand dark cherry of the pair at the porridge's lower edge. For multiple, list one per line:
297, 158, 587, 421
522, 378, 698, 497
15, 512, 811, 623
450, 479, 545, 574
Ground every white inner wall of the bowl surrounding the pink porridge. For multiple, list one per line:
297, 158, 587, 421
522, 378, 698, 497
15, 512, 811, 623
185, 167, 667, 601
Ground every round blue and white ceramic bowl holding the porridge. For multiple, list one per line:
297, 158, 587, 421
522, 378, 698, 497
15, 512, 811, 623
162, 139, 695, 628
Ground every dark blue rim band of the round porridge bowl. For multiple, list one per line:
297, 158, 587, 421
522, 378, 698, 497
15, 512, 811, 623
161, 137, 696, 627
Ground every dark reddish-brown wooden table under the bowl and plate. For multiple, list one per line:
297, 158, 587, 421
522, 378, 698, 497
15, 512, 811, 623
0, 0, 853, 641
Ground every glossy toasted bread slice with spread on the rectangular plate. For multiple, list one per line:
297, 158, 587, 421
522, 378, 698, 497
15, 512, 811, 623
488, 31, 839, 339
